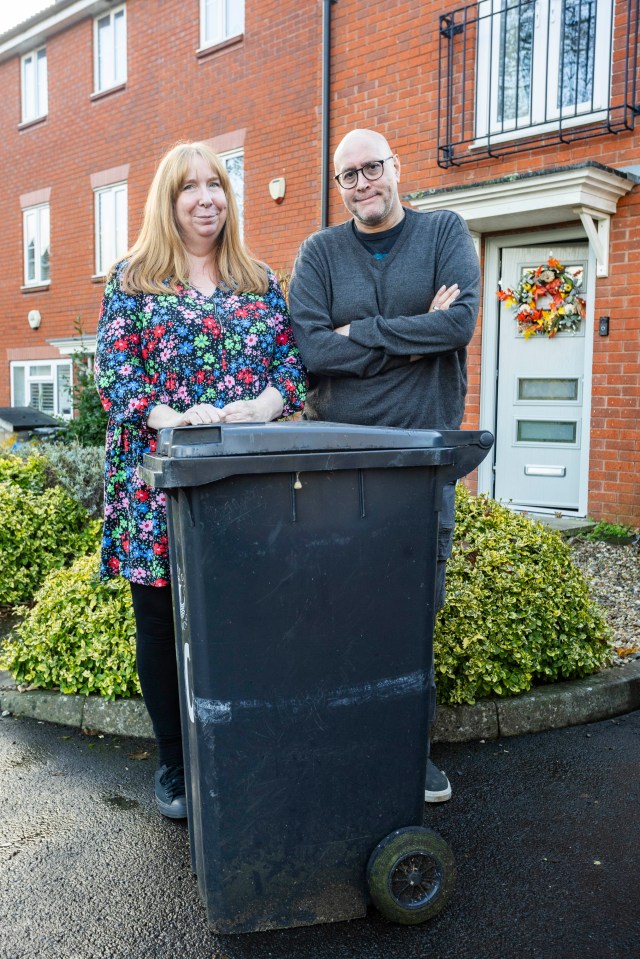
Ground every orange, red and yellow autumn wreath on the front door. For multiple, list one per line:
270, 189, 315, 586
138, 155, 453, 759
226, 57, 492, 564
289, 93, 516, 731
498, 257, 585, 339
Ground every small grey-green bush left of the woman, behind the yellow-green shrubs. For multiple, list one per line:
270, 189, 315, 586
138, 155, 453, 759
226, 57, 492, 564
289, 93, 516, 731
41, 443, 104, 519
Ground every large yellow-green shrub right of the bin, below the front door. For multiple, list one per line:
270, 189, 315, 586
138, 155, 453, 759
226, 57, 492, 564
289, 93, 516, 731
434, 485, 611, 704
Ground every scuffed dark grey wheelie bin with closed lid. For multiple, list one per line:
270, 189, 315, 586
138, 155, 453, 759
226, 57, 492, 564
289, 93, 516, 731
141, 421, 493, 933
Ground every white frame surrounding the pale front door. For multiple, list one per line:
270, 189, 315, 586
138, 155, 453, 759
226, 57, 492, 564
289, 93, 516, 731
478, 224, 596, 517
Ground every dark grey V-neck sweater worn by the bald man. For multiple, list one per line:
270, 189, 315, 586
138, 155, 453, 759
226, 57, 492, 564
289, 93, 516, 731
289, 209, 480, 429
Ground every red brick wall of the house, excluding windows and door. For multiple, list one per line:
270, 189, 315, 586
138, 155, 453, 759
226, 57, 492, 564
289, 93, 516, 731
0, 0, 640, 524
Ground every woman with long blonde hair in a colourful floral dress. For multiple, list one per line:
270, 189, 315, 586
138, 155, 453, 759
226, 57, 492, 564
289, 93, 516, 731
95, 143, 306, 819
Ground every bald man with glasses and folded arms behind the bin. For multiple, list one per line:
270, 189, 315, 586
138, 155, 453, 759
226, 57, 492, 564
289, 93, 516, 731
289, 130, 480, 802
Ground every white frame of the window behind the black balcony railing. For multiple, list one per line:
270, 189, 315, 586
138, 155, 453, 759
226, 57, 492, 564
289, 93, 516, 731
472, 0, 613, 149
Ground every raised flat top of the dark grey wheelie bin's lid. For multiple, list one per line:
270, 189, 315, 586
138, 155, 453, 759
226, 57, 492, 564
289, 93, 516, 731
156, 420, 447, 459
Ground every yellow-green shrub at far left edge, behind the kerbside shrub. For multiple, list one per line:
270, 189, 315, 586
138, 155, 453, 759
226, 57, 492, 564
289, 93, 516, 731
0, 482, 99, 606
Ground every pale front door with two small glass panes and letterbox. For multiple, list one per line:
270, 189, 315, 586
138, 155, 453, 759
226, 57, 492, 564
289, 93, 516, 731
494, 244, 589, 512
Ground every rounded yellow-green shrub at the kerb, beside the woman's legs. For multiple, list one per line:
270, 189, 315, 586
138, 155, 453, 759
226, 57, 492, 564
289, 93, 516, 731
2, 553, 140, 699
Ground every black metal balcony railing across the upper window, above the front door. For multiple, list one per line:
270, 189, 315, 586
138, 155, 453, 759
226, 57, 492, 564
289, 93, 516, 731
438, 0, 640, 168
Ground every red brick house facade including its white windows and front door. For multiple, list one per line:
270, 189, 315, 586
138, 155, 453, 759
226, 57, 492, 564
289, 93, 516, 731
0, 0, 640, 525
